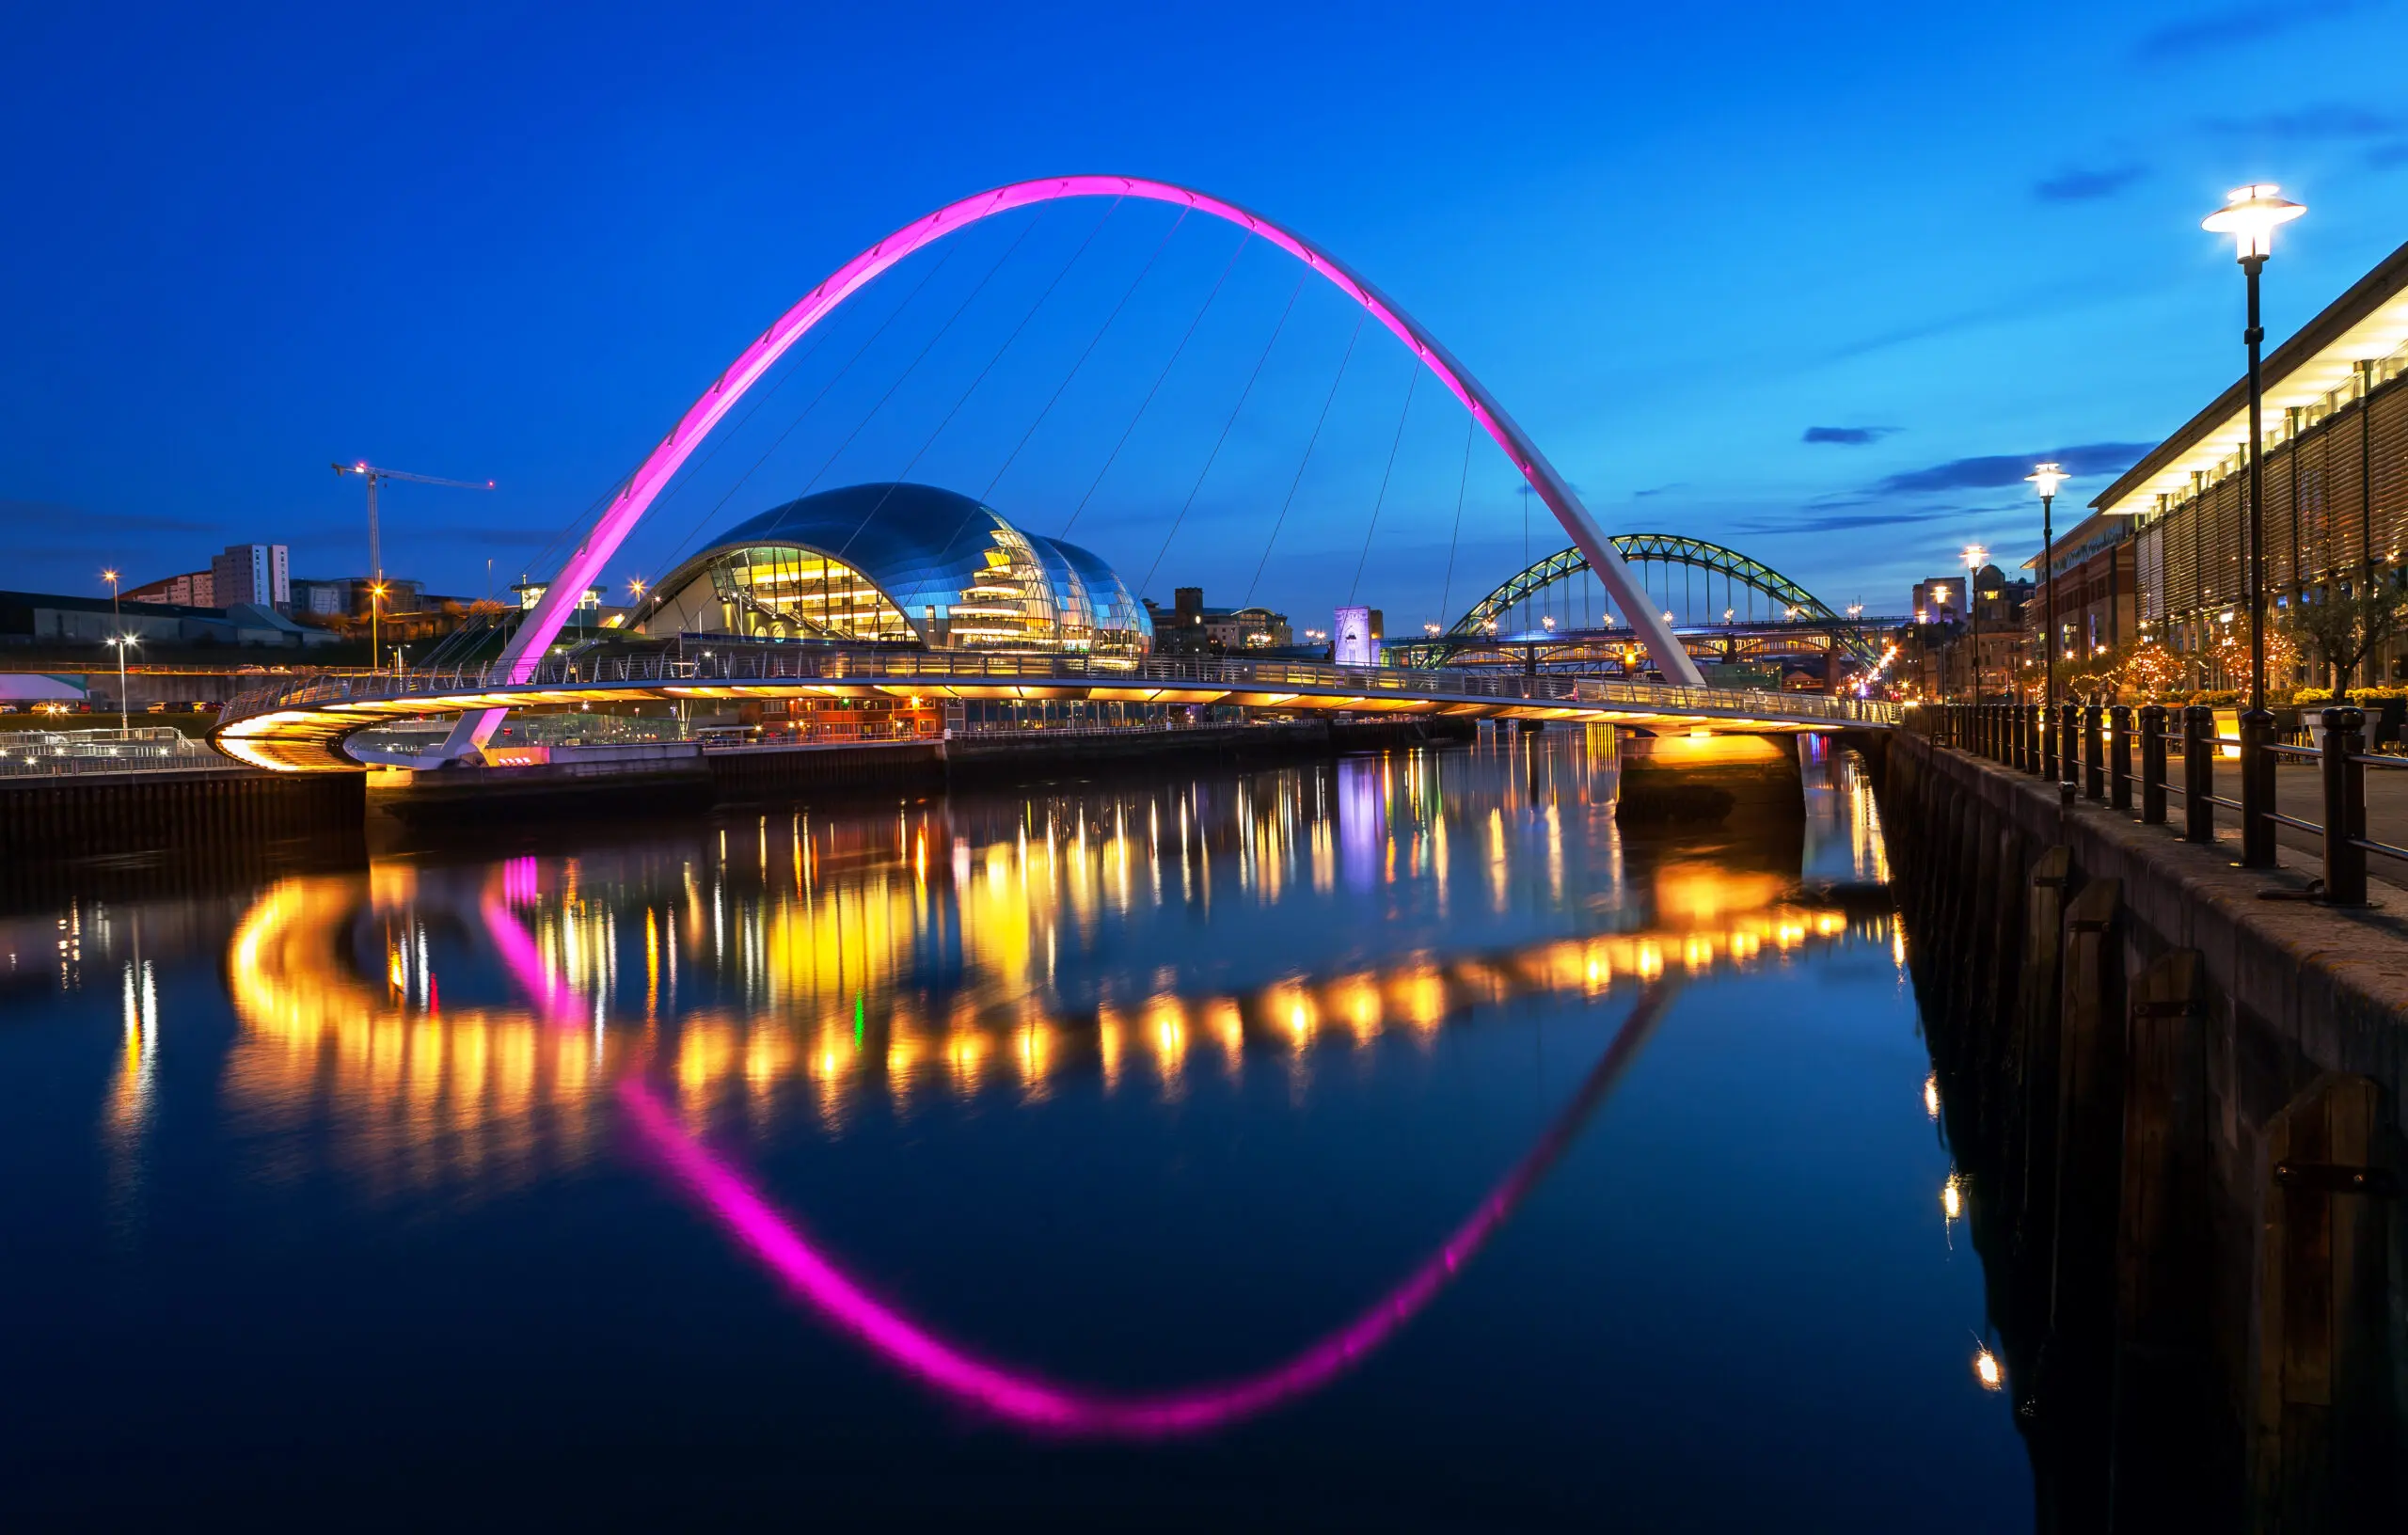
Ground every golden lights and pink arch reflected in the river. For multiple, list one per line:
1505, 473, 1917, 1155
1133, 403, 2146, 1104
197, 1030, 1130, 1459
187, 746, 1893, 1436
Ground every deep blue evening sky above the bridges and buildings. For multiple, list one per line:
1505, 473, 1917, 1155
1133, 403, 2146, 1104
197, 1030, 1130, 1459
0, 0, 2408, 630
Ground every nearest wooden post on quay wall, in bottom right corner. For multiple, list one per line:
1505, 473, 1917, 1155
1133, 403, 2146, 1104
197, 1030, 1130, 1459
2249, 1073, 2408, 1535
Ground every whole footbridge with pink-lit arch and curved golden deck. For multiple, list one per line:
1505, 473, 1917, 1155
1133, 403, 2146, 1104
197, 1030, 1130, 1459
212, 176, 1895, 772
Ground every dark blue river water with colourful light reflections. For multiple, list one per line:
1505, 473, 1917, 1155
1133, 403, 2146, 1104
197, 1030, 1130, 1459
0, 732, 2033, 1530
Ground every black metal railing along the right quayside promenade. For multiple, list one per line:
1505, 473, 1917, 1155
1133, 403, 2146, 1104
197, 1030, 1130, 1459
1908, 703, 2408, 907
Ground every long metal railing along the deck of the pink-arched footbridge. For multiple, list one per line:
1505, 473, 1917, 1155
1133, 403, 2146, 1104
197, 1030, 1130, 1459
219, 652, 1900, 727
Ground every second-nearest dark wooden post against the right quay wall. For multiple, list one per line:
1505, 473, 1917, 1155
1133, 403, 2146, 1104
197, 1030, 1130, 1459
2110, 948, 2237, 1530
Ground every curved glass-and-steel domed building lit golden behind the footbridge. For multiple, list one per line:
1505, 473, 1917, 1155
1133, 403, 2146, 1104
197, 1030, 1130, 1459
628, 483, 1153, 661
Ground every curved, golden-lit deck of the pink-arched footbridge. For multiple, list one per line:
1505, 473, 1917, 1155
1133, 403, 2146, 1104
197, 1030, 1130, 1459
210, 650, 1900, 772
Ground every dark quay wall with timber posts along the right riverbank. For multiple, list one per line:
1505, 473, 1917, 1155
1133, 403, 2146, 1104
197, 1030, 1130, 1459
1863, 732, 2408, 1530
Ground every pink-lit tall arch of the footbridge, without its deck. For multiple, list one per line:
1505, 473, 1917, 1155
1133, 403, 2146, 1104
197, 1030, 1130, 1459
446, 176, 1703, 755
